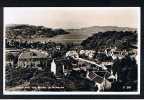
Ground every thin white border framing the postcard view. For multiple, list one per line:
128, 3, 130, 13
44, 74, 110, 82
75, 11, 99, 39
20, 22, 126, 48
3, 7, 141, 95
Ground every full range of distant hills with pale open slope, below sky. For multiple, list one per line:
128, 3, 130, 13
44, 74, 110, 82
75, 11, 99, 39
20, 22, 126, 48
6, 24, 136, 43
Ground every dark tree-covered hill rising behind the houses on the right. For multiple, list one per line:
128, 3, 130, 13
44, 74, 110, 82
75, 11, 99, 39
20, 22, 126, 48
81, 31, 137, 49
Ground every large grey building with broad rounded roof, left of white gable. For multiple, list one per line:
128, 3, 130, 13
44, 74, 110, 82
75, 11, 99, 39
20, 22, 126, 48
18, 49, 48, 67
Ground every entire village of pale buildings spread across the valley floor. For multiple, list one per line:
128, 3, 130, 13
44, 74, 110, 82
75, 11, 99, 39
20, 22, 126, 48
6, 44, 136, 91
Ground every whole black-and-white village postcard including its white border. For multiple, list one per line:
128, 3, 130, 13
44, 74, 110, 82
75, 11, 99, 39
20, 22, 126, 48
3, 7, 140, 95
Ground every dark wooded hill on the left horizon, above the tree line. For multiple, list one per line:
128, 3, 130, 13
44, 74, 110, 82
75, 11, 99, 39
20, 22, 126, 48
6, 24, 68, 39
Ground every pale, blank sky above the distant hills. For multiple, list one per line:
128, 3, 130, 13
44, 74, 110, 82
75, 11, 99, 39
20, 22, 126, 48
4, 7, 140, 28
